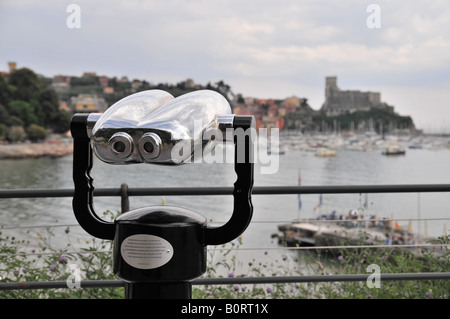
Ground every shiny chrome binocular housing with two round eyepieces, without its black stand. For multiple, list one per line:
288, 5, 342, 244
87, 90, 234, 165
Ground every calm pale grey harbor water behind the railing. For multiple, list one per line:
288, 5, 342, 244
0, 137, 450, 276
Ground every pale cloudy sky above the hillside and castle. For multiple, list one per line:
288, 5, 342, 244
0, 0, 450, 133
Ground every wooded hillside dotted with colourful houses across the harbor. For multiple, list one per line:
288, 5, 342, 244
0, 68, 415, 142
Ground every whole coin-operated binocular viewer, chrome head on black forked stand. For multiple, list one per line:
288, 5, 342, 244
71, 90, 255, 298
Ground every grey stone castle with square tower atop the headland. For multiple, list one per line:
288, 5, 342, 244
321, 76, 393, 116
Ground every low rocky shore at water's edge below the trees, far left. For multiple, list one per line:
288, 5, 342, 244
0, 143, 73, 160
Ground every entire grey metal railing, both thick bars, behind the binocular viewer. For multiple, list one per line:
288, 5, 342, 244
0, 184, 450, 290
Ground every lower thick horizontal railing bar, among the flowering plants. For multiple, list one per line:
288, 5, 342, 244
0, 272, 450, 290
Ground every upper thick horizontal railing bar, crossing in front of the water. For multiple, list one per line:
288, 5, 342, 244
0, 184, 450, 198
